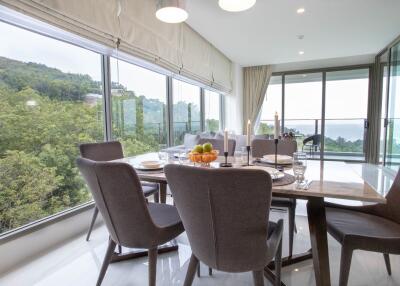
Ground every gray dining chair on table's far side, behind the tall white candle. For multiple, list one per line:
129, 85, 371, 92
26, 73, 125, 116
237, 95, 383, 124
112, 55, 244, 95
251, 139, 297, 256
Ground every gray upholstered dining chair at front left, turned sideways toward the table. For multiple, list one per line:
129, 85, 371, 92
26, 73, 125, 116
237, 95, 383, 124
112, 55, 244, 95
77, 158, 184, 286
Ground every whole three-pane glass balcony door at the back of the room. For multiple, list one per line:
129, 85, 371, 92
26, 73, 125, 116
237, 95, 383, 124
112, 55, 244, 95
258, 68, 369, 161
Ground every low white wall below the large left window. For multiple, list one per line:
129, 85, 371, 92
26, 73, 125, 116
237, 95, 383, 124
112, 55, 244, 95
0, 209, 102, 275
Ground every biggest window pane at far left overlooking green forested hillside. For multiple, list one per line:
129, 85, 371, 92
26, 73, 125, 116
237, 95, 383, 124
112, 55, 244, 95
0, 22, 104, 233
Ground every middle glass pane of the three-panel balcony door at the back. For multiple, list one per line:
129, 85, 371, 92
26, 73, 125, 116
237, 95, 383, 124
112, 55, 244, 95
285, 73, 322, 150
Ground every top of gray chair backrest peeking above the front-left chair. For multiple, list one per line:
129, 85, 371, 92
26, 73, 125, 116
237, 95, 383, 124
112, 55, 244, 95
79, 141, 124, 161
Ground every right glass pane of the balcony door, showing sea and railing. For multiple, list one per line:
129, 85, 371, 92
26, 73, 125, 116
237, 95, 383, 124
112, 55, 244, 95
324, 69, 369, 161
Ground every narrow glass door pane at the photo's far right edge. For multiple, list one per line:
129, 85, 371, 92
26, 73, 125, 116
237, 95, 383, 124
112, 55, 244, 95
386, 43, 400, 170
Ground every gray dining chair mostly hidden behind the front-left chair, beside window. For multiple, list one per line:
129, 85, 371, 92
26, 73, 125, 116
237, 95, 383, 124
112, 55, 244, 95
79, 141, 159, 241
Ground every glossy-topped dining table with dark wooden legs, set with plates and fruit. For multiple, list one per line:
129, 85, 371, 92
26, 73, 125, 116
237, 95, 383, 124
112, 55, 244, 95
116, 153, 393, 286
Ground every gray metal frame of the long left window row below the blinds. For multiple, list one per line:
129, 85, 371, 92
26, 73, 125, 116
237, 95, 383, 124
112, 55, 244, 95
0, 15, 225, 239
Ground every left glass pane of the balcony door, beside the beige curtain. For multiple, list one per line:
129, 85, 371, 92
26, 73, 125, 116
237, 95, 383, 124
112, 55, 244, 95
257, 76, 282, 135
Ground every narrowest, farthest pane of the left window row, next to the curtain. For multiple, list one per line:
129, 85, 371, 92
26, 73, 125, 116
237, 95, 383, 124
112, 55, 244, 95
204, 89, 221, 132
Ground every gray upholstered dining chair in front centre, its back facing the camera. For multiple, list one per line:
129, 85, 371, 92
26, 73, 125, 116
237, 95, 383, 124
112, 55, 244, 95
165, 164, 283, 286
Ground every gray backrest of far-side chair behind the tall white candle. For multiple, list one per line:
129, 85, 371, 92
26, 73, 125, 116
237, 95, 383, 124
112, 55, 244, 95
251, 139, 297, 158
